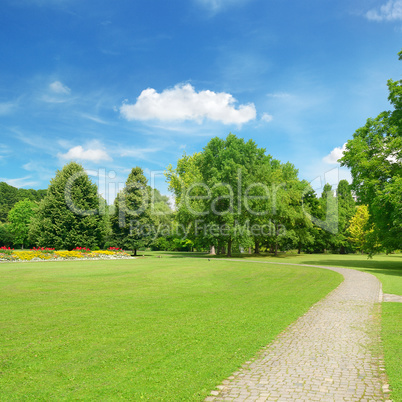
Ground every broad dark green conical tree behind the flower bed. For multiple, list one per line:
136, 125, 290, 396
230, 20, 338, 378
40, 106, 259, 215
30, 162, 106, 250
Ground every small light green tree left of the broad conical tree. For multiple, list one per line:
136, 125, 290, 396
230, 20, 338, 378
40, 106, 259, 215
8, 199, 37, 248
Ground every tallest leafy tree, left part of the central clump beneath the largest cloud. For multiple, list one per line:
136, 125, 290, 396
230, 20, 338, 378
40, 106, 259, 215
166, 134, 268, 255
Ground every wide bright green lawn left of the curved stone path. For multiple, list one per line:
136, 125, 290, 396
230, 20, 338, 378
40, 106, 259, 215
0, 256, 342, 401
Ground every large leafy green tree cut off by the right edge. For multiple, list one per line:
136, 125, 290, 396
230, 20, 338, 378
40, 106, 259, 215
340, 52, 402, 253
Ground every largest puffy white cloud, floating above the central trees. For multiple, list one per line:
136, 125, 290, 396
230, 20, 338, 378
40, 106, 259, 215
120, 84, 256, 125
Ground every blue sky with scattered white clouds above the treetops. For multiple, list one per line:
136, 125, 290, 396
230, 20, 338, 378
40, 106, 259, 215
0, 0, 402, 202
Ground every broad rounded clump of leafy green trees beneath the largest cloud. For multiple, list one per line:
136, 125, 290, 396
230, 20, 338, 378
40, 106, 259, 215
166, 134, 311, 255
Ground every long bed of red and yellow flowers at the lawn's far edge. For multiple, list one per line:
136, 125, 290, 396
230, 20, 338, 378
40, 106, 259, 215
0, 247, 130, 261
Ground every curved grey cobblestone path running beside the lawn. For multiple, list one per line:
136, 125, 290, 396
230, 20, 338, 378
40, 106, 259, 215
205, 260, 388, 402
